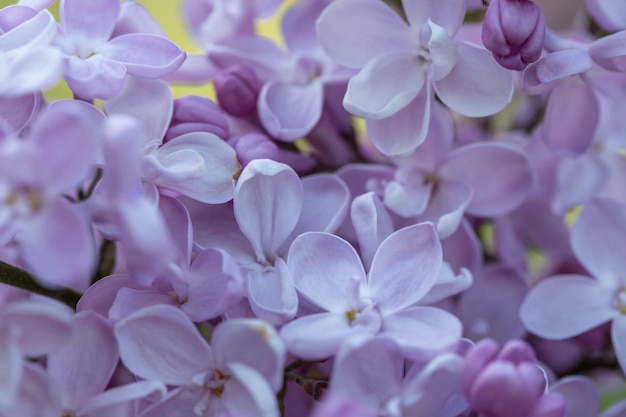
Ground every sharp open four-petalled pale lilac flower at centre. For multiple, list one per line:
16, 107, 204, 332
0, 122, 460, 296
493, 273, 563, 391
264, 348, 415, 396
280, 223, 461, 359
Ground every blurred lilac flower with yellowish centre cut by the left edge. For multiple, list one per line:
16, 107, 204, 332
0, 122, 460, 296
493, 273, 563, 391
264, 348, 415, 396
0, 101, 101, 290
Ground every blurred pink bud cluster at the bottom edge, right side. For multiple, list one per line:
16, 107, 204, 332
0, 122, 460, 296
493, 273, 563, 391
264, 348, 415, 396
463, 339, 565, 417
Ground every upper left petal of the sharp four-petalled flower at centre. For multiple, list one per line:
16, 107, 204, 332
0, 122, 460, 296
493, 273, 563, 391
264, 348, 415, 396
287, 232, 365, 312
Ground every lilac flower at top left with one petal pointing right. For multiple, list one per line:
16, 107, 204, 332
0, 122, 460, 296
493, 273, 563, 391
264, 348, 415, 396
56, 0, 185, 100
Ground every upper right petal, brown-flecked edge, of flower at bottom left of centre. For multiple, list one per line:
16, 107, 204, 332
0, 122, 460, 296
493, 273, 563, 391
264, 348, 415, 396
211, 319, 286, 392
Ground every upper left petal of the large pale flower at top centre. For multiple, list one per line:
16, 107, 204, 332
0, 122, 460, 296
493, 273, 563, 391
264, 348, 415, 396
317, 0, 414, 68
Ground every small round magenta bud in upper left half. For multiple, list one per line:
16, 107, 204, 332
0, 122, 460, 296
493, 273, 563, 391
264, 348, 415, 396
213, 65, 261, 117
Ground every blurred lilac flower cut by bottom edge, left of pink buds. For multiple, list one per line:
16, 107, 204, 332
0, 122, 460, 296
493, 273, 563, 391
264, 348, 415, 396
329, 338, 467, 417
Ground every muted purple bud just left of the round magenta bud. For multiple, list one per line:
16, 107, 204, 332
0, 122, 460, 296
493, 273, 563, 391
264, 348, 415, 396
165, 96, 229, 142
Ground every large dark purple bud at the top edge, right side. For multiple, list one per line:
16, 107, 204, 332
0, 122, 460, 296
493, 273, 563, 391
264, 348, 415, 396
482, 0, 546, 71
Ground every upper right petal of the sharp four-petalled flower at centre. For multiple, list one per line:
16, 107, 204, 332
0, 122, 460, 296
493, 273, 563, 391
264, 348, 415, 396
368, 223, 442, 314
